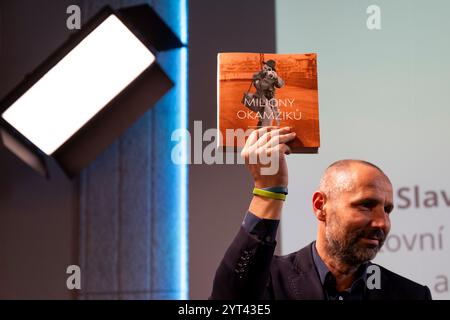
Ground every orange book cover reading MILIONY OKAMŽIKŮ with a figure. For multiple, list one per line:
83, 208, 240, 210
217, 53, 320, 153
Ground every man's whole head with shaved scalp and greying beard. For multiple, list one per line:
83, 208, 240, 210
312, 160, 394, 269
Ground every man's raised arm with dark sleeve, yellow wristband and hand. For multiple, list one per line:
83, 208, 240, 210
211, 127, 295, 299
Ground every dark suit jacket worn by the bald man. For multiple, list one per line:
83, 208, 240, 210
210, 227, 431, 300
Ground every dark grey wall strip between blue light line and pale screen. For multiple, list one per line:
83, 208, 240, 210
189, 0, 275, 299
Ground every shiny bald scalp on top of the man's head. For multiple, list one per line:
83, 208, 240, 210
319, 159, 391, 199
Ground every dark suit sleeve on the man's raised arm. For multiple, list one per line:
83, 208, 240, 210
210, 222, 276, 300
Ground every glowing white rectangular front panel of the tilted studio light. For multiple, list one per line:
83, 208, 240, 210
2, 15, 155, 155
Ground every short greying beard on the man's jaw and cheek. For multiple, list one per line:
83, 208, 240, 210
325, 212, 386, 266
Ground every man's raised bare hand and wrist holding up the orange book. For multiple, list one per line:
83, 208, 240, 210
241, 127, 295, 219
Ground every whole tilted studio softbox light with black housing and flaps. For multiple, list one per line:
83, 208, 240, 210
0, 5, 182, 176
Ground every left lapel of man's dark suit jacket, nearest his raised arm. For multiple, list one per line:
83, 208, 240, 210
289, 243, 325, 300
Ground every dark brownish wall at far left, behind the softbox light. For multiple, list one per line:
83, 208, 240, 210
0, 0, 82, 299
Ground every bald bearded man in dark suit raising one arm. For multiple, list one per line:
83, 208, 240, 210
210, 127, 431, 300
